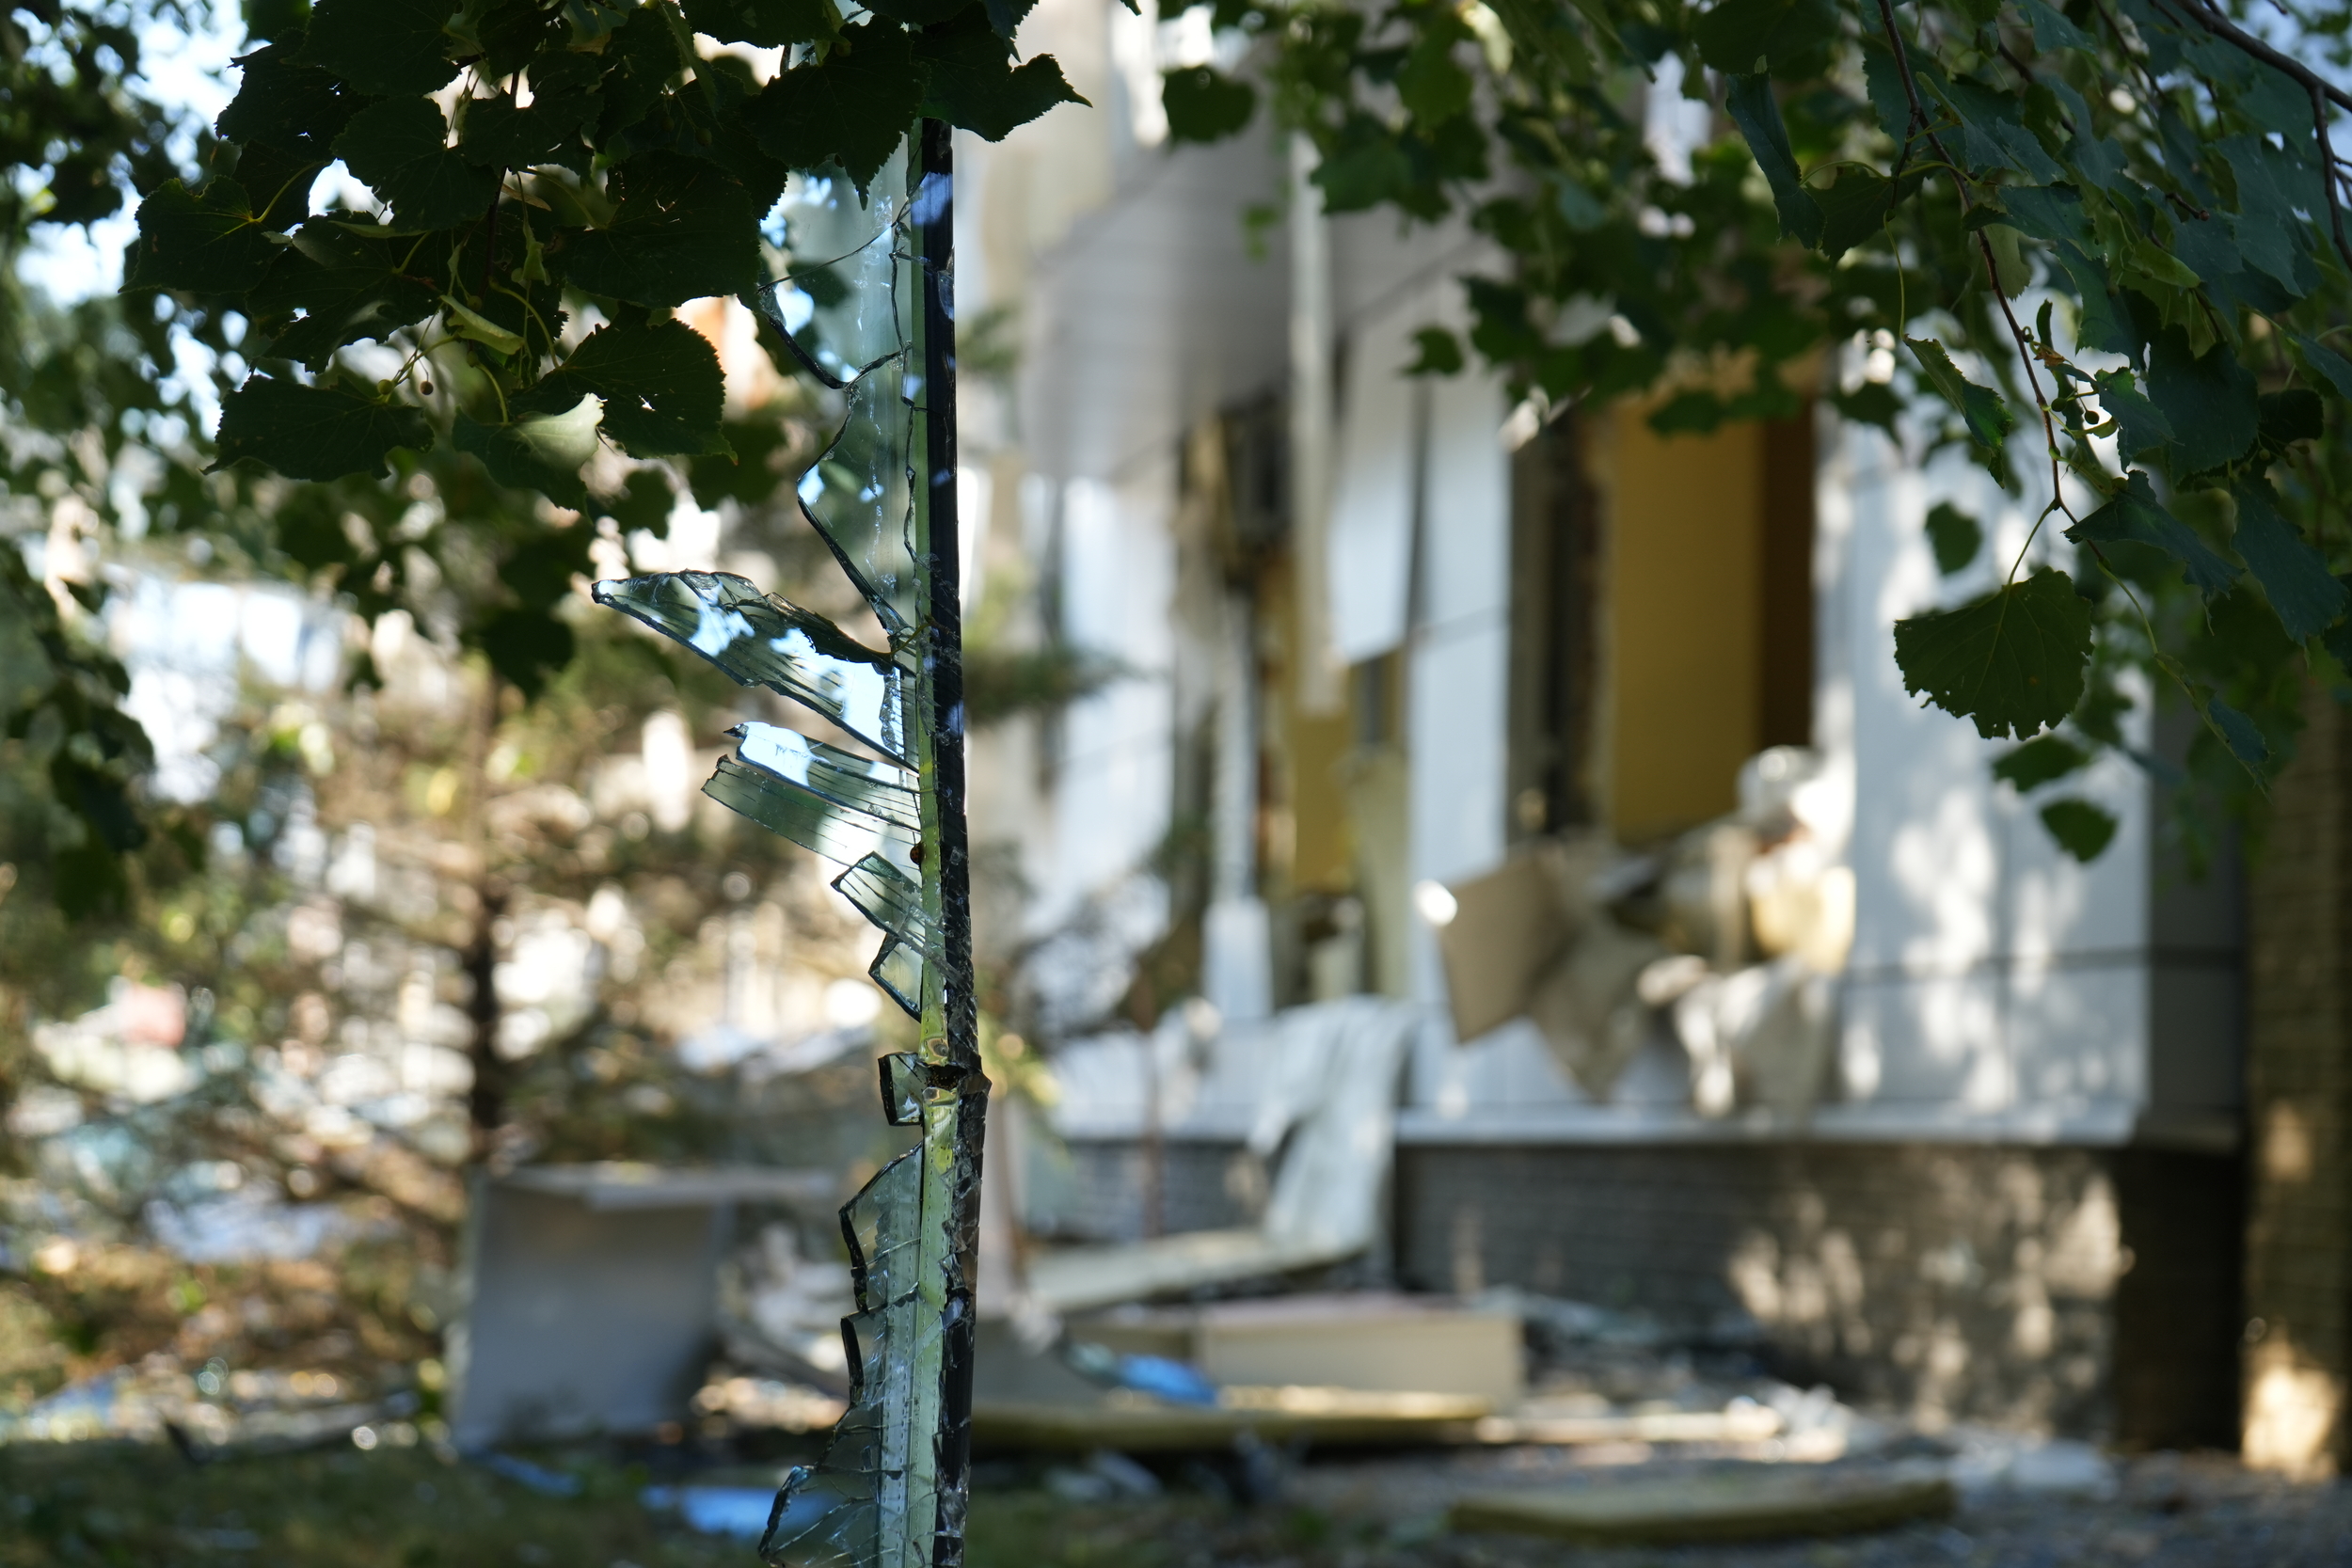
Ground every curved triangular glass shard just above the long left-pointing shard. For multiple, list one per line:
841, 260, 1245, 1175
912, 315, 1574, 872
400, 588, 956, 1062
800, 359, 917, 641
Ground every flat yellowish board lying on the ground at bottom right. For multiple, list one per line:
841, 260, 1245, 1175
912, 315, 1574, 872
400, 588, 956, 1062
1449, 1465, 1955, 1547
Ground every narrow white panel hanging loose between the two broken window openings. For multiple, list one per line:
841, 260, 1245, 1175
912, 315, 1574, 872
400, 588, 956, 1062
1327, 298, 1428, 663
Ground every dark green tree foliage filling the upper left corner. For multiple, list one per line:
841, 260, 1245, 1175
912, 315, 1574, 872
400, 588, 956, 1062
0, 0, 1075, 912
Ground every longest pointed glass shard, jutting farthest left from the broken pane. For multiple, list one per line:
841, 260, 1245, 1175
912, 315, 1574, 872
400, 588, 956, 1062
596, 571, 915, 762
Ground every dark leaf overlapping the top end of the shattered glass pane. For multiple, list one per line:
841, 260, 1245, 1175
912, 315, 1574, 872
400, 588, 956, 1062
743, 21, 925, 193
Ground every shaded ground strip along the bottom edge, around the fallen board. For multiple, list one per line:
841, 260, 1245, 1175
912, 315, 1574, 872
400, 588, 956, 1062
0, 1444, 2352, 1568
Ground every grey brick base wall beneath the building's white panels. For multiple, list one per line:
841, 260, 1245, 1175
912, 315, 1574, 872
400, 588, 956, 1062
1395, 1145, 2239, 1446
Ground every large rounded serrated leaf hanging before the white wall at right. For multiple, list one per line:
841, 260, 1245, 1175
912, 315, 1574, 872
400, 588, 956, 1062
1896, 566, 2091, 740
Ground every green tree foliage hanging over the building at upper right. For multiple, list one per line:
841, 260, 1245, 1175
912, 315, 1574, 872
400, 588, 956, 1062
1165, 0, 2352, 853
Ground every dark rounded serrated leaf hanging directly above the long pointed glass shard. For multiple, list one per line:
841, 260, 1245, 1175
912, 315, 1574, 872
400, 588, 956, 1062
524, 320, 727, 458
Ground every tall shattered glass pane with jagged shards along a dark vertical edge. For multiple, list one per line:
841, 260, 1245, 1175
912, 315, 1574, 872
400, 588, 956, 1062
596, 119, 988, 1568
